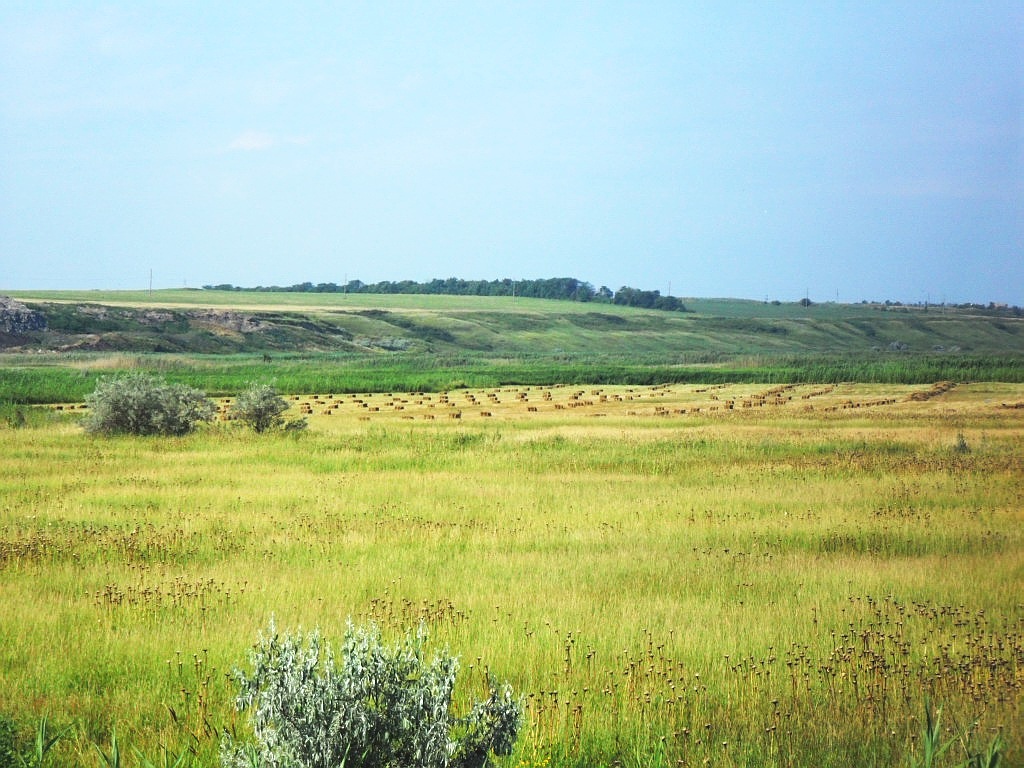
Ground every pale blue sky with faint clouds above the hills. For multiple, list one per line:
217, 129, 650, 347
0, 0, 1024, 305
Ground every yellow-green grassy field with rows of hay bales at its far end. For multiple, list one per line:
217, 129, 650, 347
0, 383, 1024, 768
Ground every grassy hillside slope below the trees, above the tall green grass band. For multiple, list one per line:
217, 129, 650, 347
8, 291, 1024, 369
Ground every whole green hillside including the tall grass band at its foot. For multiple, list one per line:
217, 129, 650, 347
0, 290, 1024, 402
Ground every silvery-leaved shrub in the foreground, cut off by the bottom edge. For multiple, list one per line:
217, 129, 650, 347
221, 623, 522, 768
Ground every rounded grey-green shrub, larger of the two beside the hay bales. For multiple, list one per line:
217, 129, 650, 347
83, 373, 216, 435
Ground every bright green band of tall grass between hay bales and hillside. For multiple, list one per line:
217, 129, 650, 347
0, 353, 1024, 403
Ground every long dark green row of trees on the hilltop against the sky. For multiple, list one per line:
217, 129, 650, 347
203, 278, 686, 312
